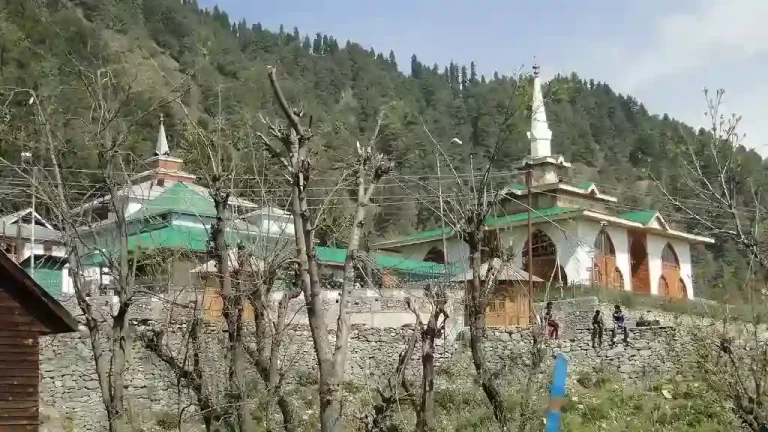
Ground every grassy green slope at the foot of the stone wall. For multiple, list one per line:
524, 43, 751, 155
134, 368, 740, 432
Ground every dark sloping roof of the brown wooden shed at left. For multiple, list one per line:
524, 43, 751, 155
0, 252, 78, 333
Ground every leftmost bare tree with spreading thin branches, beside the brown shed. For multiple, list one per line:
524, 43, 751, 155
4, 62, 184, 431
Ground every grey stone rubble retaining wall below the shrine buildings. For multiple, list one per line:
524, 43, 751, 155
40, 300, 712, 431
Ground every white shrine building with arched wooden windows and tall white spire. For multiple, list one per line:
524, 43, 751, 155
375, 66, 714, 299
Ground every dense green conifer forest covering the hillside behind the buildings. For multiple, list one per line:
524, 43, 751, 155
0, 0, 765, 298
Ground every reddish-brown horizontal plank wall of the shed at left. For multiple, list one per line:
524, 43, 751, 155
0, 289, 44, 432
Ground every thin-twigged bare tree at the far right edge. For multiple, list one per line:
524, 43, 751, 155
656, 90, 768, 432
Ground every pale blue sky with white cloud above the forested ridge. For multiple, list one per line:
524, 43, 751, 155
198, 0, 768, 155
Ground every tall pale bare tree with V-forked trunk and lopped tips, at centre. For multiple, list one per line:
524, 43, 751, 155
261, 67, 392, 431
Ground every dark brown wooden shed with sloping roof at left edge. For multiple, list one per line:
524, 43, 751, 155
0, 252, 77, 432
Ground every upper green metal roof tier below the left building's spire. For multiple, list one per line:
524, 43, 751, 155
128, 182, 216, 220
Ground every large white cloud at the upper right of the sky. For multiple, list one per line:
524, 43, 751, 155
575, 0, 768, 156
